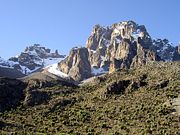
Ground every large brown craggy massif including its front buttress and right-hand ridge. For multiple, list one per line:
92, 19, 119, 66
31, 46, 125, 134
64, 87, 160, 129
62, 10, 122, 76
58, 21, 180, 81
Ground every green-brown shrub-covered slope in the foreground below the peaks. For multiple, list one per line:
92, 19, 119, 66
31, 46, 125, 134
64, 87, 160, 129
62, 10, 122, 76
0, 62, 180, 135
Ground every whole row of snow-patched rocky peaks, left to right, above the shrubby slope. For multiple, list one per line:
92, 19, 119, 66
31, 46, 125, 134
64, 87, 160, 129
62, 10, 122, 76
0, 21, 180, 81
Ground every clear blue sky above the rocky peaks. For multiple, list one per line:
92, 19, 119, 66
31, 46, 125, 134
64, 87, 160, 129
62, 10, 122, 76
0, 0, 180, 59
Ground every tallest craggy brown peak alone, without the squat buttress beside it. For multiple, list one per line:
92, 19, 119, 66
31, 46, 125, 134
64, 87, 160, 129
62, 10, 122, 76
86, 21, 158, 72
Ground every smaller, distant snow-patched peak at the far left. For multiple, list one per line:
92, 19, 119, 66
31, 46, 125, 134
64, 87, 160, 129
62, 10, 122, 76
0, 44, 65, 75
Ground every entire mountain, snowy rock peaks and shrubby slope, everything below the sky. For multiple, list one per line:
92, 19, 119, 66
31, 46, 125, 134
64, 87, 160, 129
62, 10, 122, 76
0, 21, 180, 135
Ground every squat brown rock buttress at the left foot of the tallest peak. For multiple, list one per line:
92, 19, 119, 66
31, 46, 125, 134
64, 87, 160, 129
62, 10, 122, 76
58, 48, 91, 81
